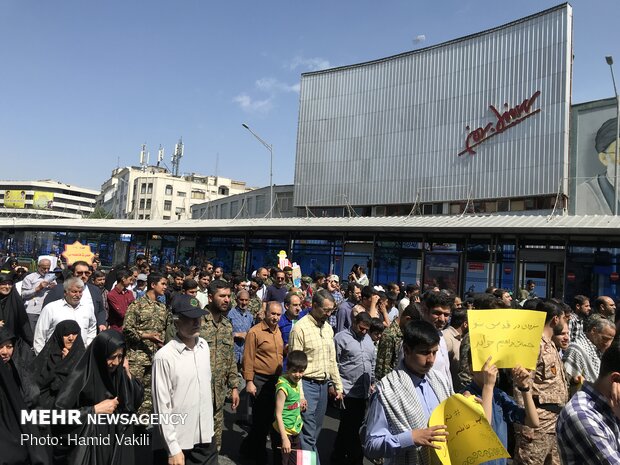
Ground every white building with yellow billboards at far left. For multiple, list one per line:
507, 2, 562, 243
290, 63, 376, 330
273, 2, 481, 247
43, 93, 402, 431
0, 179, 99, 219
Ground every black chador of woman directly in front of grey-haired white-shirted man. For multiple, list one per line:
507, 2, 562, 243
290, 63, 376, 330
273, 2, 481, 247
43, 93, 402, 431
33, 320, 85, 409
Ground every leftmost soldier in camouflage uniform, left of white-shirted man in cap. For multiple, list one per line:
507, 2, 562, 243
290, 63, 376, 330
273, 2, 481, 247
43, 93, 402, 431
123, 273, 168, 414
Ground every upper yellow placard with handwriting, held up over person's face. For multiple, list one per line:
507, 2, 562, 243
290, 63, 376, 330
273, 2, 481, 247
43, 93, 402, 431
467, 310, 546, 371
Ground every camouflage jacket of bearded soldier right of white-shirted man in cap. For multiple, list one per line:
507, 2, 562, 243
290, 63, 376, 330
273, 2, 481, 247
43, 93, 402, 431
200, 313, 239, 410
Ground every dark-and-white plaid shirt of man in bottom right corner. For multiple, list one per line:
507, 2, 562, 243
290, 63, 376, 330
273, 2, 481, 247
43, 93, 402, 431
556, 383, 620, 465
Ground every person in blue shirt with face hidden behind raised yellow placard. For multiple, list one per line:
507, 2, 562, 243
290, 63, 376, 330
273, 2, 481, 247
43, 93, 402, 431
463, 354, 539, 465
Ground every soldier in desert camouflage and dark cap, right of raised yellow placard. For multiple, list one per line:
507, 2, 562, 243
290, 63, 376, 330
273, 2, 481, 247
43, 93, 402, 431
513, 302, 568, 465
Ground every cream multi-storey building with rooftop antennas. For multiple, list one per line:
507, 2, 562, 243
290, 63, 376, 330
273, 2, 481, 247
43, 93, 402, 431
98, 166, 252, 220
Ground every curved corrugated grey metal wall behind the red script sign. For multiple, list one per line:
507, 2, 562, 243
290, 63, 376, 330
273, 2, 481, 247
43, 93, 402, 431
294, 5, 572, 206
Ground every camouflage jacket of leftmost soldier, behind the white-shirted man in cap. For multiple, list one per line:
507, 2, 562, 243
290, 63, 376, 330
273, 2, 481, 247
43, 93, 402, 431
123, 295, 168, 365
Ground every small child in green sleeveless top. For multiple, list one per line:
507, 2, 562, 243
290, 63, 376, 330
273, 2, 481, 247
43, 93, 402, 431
271, 350, 308, 465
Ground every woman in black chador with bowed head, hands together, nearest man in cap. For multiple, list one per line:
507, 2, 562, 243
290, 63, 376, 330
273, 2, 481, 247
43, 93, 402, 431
53, 329, 144, 465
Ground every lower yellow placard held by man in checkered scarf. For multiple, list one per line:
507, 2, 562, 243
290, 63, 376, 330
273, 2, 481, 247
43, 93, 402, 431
428, 394, 510, 465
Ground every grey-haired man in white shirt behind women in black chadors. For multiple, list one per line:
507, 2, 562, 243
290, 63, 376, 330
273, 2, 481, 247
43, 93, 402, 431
33, 278, 97, 354
